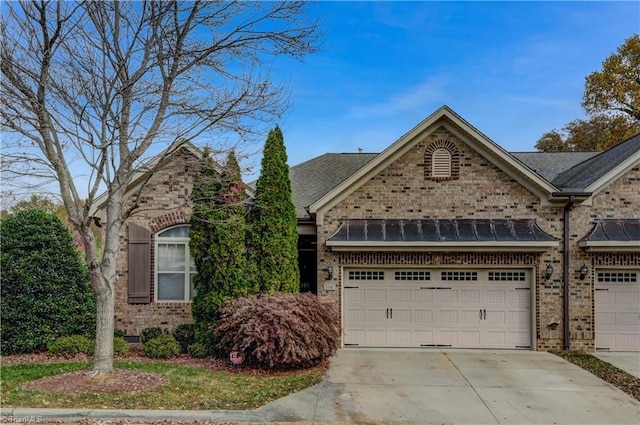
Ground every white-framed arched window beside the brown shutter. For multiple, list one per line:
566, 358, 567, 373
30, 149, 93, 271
155, 225, 196, 301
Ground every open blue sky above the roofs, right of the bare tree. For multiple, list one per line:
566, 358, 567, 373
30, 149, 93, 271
258, 1, 640, 174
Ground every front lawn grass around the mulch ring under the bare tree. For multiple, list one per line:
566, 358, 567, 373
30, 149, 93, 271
0, 361, 323, 410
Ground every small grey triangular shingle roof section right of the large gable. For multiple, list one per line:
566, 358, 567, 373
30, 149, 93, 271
511, 152, 600, 182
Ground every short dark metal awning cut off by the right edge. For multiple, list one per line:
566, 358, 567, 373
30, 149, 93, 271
578, 218, 640, 252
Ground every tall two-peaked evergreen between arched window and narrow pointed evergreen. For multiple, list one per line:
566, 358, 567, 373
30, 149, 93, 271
189, 150, 257, 354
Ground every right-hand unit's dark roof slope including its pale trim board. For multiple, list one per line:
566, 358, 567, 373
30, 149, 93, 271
553, 134, 640, 192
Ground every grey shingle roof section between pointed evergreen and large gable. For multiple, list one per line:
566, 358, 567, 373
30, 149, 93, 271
289, 153, 378, 218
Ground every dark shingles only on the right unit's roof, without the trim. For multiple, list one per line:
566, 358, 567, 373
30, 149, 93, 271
552, 134, 640, 189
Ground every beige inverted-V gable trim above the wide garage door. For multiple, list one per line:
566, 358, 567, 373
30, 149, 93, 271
309, 105, 557, 221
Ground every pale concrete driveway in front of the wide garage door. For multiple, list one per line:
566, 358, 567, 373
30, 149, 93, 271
256, 349, 640, 425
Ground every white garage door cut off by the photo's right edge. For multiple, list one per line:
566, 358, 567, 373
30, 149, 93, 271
595, 270, 640, 351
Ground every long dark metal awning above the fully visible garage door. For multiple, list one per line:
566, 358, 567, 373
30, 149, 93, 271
326, 218, 559, 252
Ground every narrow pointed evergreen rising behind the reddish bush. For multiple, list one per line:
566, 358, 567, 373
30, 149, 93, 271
249, 126, 300, 293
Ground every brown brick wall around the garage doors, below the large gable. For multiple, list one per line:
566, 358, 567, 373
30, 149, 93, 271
318, 127, 640, 351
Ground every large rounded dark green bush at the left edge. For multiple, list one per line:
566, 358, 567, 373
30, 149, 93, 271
0, 210, 96, 355
